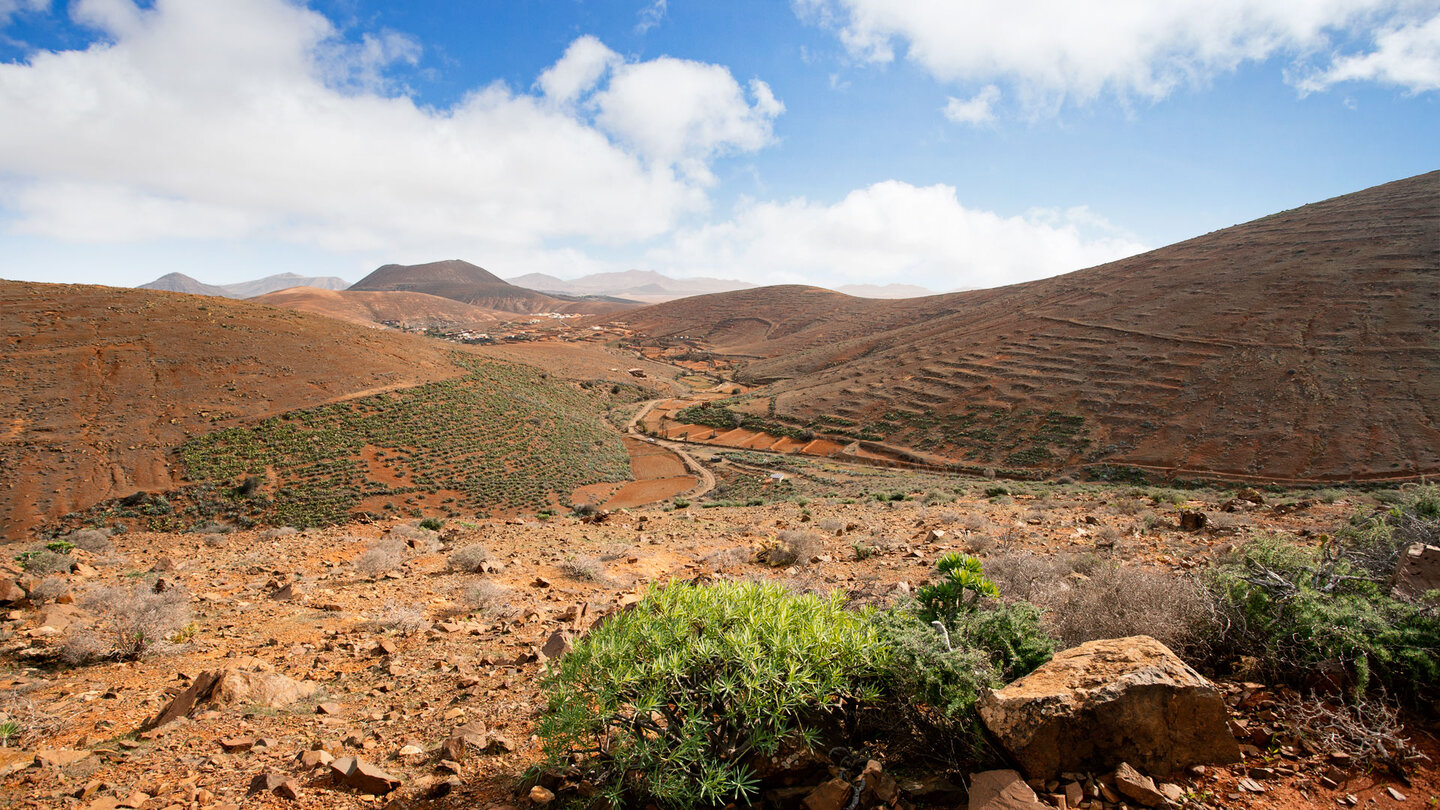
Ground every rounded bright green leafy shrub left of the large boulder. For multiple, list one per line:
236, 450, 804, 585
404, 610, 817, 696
539, 582, 890, 807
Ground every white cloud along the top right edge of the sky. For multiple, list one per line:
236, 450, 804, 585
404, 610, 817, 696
793, 0, 1434, 110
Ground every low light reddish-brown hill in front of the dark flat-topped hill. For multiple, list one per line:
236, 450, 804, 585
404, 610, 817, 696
252, 287, 514, 329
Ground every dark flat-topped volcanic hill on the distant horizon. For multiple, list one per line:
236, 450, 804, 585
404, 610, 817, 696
350, 259, 634, 314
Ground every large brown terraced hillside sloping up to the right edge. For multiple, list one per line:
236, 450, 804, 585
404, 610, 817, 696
626, 172, 1440, 481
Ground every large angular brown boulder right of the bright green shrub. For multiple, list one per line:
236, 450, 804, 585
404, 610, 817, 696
978, 636, 1240, 780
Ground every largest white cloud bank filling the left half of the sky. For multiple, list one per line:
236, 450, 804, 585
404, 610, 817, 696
0, 0, 783, 257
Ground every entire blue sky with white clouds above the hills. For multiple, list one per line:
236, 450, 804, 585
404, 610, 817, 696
0, 0, 1440, 290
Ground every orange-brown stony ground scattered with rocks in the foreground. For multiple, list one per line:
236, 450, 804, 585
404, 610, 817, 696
0, 471, 1440, 810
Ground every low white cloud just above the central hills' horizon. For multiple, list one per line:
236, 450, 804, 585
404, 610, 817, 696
647, 180, 1146, 290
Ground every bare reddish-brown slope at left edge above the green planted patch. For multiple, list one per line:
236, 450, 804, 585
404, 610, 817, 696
0, 281, 465, 540
